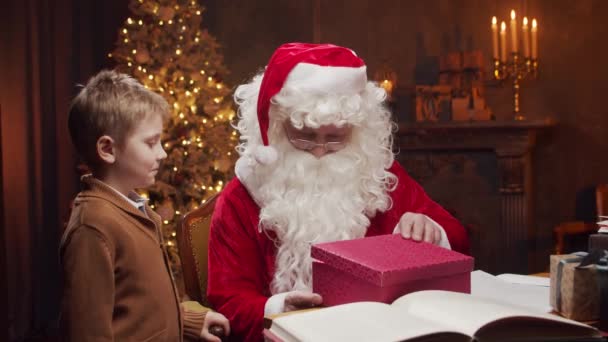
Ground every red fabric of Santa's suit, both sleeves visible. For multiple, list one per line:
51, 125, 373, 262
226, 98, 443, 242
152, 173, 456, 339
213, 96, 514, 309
207, 162, 469, 341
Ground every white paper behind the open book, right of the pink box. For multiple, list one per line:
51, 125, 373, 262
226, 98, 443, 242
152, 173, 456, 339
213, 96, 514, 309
471, 271, 552, 313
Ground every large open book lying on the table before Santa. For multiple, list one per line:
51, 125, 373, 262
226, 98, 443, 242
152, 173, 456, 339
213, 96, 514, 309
265, 290, 602, 342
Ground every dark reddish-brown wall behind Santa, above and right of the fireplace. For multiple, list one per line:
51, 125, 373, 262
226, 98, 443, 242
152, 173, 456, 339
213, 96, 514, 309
205, 0, 608, 270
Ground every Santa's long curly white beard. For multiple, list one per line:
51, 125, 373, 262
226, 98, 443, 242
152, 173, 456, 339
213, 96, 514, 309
246, 140, 390, 294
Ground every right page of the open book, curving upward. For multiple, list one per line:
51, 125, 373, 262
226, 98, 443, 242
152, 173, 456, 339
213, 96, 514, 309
393, 290, 594, 336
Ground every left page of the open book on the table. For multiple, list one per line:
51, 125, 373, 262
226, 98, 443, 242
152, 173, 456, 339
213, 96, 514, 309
271, 302, 470, 341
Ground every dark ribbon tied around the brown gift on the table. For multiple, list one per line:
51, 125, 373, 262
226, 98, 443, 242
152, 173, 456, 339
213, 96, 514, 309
555, 249, 608, 327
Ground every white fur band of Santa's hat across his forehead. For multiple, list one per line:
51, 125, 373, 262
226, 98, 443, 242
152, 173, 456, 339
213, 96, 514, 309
283, 63, 367, 94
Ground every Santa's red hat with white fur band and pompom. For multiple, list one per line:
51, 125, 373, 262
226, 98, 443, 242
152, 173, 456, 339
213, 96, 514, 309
254, 43, 367, 164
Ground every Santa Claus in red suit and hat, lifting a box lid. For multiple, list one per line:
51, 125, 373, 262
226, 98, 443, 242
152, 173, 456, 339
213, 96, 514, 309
207, 43, 468, 341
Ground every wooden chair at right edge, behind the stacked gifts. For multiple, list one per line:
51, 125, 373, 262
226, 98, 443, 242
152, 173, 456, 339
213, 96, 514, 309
553, 184, 608, 254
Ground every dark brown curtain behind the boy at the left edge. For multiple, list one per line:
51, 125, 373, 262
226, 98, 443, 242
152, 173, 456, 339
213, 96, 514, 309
0, 0, 128, 341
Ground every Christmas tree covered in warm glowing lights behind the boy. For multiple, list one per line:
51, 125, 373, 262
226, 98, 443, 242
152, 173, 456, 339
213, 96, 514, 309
109, 0, 237, 276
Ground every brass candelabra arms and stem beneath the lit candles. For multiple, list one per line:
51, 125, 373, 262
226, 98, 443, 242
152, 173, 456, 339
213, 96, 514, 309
494, 52, 538, 121
